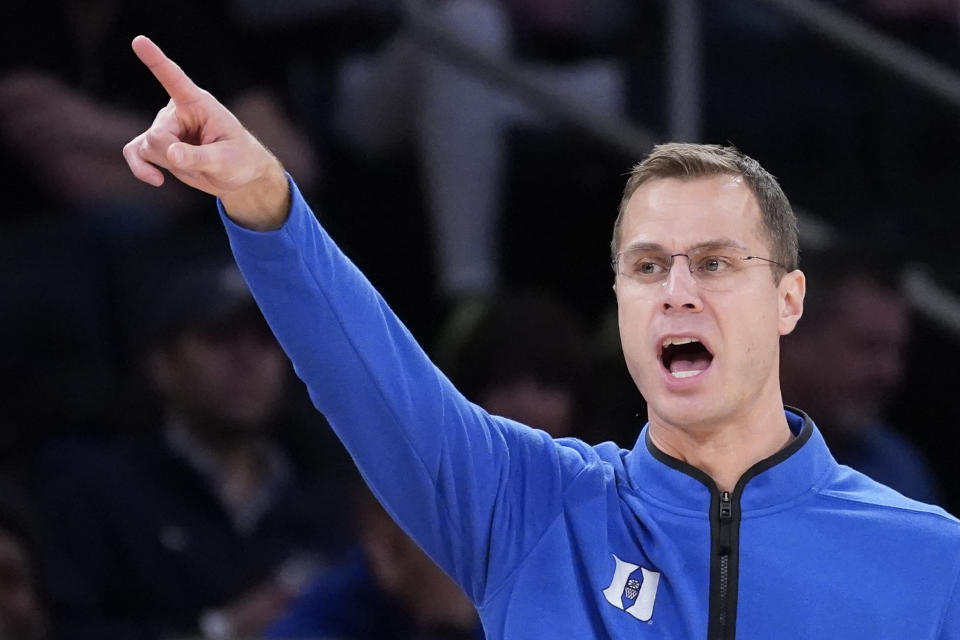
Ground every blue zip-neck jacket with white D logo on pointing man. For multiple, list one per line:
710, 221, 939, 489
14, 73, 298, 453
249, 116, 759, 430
225, 180, 960, 640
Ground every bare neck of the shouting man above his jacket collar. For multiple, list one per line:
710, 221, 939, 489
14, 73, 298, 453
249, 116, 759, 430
650, 399, 793, 491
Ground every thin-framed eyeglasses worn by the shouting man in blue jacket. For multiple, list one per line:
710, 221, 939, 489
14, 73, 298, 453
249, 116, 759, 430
610, 247, 790, 292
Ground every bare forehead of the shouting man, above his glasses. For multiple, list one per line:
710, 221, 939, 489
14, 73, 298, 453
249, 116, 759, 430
620, 175, 763, 250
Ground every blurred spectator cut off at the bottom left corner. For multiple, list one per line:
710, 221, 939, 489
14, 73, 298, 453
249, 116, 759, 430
0, 484, 47, 640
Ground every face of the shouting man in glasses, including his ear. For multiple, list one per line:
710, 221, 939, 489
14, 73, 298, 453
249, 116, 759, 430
615, 176, 804, 428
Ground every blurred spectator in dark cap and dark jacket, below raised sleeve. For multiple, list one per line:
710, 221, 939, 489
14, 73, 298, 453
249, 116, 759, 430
38, 241, 349, 640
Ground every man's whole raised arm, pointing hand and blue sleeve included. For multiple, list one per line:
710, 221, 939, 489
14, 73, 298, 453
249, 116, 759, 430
124, 37, 595, 602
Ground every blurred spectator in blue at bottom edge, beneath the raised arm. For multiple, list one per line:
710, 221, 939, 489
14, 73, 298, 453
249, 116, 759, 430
266, 487, 483, 640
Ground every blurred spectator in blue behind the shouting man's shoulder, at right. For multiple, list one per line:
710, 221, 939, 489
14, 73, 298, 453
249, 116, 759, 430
781, 249, 941, 504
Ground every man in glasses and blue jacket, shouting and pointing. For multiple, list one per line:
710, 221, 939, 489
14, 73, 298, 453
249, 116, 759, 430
124, 37, 960, 640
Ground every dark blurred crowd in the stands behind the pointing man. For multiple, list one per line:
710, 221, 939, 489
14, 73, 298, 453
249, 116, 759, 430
0, 0, 960, 640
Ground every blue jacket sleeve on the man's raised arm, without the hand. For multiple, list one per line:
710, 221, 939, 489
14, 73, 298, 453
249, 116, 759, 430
220, 181, 591, 604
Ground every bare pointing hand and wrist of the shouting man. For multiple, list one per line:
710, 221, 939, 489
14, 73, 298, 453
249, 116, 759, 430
123, 36, 290, 231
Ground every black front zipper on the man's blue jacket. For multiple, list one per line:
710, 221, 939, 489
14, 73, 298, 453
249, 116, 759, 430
708, 491, 737, 640
